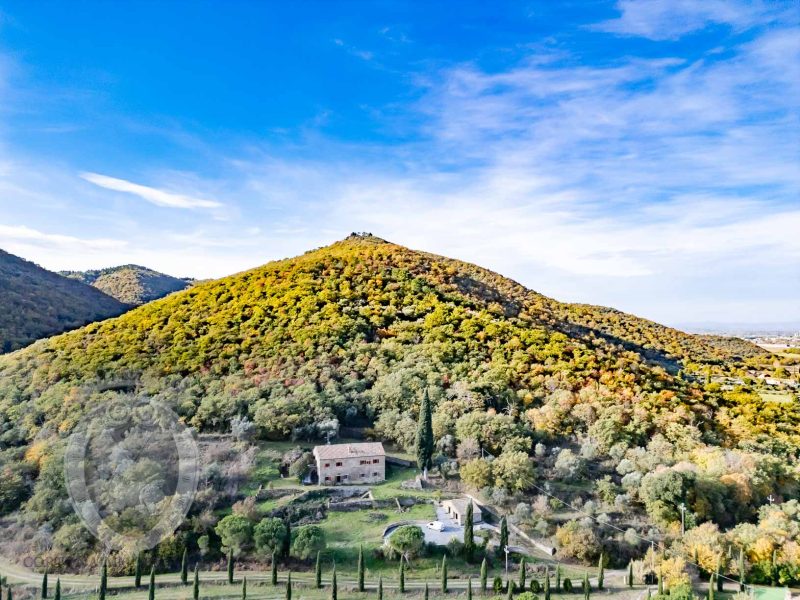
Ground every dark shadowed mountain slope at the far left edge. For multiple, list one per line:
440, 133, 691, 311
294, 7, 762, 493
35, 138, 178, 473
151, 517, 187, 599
0, 250, 130, 352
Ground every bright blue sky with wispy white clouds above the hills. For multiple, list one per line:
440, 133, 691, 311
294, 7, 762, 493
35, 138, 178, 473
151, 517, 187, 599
0, 0, 800, 324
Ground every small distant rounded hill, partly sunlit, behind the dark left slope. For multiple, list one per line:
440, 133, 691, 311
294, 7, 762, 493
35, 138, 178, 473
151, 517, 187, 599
61, 265, 192, 305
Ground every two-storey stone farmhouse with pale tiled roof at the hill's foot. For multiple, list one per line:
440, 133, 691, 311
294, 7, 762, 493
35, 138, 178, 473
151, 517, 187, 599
314, 442, 386, 485
